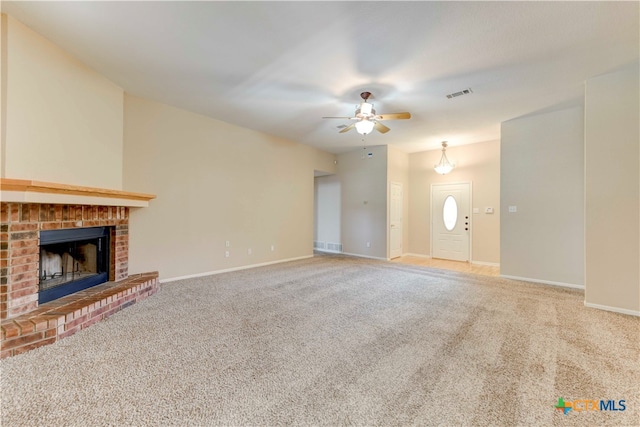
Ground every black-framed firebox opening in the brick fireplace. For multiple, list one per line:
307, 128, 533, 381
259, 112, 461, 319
38, 227, 110, 304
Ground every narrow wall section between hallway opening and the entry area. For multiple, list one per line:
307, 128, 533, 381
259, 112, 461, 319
338, 146, 388, 259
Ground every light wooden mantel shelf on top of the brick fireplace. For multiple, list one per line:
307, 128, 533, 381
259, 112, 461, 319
0, 178, 156, 207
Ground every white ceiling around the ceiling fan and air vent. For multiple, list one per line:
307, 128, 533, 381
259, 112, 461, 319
2, 1, 640, 153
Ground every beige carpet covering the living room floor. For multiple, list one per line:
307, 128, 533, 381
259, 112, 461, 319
0, 255, 640, 427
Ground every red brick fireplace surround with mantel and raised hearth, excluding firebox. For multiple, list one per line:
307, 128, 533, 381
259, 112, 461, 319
0, 179, 158, 357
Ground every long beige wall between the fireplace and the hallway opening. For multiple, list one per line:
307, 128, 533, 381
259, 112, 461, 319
124, 95, 335, 279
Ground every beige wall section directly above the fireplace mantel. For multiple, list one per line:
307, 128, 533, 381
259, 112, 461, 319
0, 16, 123, 189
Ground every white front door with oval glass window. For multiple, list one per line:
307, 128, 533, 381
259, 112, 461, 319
431, 183, 471, 261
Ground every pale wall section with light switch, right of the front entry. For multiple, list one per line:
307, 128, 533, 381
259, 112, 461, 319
500, 107, 584, 286
